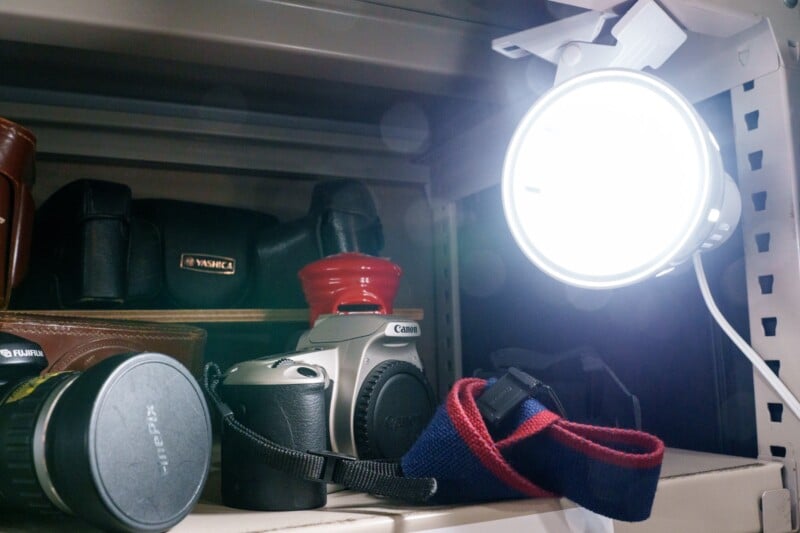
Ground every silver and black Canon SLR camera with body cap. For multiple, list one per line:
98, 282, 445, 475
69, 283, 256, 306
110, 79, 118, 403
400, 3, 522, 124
220, 313, 436, 510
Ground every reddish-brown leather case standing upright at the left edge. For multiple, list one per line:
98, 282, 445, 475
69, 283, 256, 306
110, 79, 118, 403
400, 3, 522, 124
0, 118, 36, 309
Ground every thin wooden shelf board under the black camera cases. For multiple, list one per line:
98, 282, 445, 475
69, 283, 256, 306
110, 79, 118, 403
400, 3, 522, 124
6, 308, 424, 324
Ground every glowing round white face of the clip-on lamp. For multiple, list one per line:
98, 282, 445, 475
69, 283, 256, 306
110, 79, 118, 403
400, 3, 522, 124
503, 69, 724, 288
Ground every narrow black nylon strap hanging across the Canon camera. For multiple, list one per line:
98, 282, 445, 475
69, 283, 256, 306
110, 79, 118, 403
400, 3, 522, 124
203, 363, 436, 503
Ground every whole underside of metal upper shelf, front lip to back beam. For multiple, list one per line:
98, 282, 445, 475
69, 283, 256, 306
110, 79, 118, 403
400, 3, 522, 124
0, 0, 574, 199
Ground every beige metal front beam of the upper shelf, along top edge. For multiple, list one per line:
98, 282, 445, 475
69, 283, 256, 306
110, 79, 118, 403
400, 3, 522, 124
0, 0, 550, 98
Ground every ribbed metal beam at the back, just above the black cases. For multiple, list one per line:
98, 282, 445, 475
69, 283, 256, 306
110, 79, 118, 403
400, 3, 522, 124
0, 86, 429, 184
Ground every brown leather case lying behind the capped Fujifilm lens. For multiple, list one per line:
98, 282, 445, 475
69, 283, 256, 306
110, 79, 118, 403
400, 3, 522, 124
0, 312, 206, 376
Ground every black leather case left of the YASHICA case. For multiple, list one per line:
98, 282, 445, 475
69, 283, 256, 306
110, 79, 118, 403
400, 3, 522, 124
14, 180, 162, 309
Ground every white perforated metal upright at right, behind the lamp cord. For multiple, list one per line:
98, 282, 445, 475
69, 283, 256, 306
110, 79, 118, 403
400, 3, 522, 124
731, 1, 800, 529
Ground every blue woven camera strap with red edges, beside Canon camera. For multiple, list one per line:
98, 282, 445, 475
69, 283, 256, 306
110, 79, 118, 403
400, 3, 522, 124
401, 378, 664, 521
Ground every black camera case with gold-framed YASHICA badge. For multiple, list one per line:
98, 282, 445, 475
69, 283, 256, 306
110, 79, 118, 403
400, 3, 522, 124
131, 199, 278, 309
